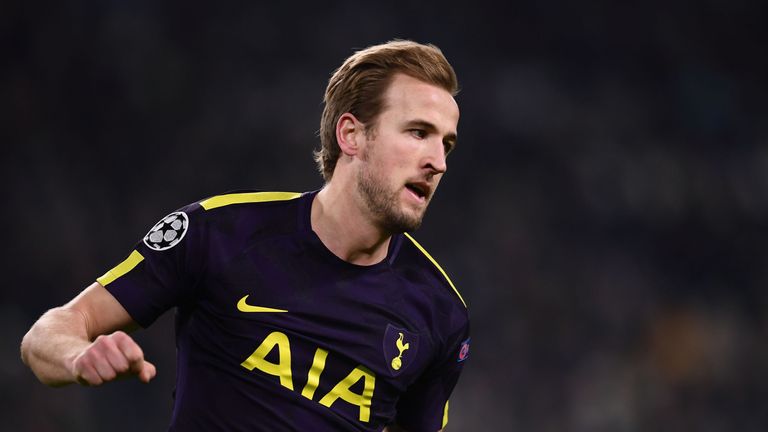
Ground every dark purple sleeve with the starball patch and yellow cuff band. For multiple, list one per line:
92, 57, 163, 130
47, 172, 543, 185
97, 204, 205, 327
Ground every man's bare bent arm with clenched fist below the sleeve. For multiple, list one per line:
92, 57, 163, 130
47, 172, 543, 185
21, 282, 156, 386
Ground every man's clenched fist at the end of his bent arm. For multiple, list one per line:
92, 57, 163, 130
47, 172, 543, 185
72, 331, 157, 386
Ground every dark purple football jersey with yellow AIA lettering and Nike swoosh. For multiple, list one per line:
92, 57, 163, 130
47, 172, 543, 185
98, 192, 469, 432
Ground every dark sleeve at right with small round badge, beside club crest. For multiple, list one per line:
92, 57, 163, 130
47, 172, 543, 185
396, 323, 470, 432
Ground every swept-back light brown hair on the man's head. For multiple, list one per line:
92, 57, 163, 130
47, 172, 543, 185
315, 40, 459, 182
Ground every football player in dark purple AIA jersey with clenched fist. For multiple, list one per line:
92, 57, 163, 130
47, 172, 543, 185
21, 41, 469, 432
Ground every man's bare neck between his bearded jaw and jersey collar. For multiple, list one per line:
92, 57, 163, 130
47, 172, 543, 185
311, 183, 392, 265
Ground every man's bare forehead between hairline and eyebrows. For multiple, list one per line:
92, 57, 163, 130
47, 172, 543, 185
382, 73, 459, 128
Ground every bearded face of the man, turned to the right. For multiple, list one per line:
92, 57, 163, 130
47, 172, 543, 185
357, 74, 459, 232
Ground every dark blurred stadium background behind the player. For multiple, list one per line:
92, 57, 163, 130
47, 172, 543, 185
0, 0, 768, 432
